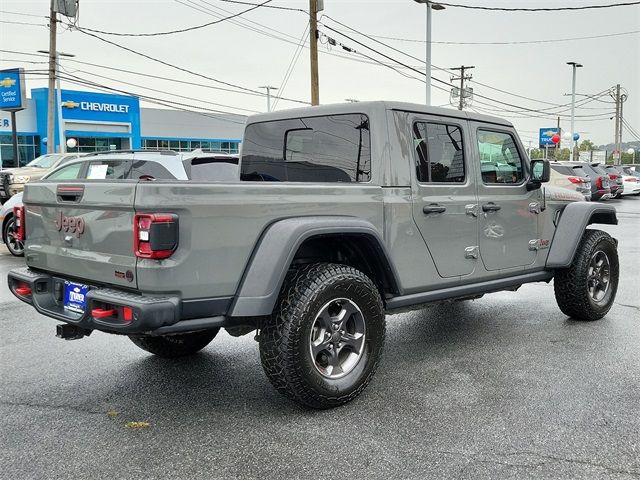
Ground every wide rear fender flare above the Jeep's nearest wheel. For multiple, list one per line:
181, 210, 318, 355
229, 216, 399, 317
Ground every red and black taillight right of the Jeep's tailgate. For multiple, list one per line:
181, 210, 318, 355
133, 213, 178, 260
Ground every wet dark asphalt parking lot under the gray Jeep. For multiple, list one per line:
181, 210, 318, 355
0, 197, 640, 480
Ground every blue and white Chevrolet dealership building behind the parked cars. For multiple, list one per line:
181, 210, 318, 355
0, 88, 246, 168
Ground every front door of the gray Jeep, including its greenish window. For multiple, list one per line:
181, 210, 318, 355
474, 124, 542, 270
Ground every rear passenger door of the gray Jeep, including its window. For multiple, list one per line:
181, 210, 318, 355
411, 116, 478, 278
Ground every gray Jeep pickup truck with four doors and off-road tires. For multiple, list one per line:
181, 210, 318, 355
8, 102, 618, 408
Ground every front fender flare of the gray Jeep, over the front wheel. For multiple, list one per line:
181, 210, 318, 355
546, 202, 618, 269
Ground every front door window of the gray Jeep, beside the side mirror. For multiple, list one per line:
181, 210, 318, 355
478, 130, 524, 184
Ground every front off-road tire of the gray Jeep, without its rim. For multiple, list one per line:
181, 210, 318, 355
553, 230, 619, 321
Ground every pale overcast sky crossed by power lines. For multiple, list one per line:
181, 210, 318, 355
0, 0, 640, 146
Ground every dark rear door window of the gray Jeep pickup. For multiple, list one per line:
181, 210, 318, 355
413, 122, 465, 183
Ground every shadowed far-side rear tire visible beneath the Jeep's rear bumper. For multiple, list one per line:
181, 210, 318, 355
129, 328, 220, 358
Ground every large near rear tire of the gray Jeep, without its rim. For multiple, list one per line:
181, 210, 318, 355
259, 263, 385, 409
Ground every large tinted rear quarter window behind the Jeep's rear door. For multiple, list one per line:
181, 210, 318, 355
241, 114, 371, 182
